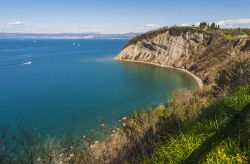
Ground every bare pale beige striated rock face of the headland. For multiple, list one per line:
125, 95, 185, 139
116, 31, 210, 67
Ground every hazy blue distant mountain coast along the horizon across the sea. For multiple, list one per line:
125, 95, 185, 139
0, 33, 139, 39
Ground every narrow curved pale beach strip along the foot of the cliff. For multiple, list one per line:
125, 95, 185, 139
114, 58, 204, 89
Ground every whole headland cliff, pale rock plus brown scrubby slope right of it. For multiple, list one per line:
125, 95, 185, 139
115, 27, 249, 84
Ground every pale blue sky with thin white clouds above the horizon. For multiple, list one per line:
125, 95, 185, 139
0, 0, 250, 33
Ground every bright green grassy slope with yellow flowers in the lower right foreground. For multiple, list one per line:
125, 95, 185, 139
144, 87, 250, 163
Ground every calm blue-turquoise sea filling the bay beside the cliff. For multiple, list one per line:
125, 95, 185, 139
0, 40, 196, 135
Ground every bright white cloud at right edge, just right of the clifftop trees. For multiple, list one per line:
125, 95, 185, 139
215, 19, 250, 28
